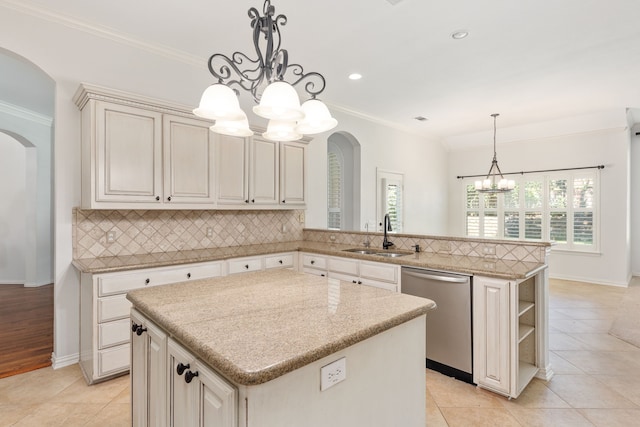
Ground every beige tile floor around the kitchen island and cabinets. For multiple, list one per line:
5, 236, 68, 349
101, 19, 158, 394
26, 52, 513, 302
0, 278, 640, 427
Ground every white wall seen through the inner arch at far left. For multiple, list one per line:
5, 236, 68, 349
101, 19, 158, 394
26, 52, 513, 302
0, 132, 26, 285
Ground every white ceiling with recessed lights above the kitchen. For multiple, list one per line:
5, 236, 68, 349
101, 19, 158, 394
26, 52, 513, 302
3, 0, 640, 138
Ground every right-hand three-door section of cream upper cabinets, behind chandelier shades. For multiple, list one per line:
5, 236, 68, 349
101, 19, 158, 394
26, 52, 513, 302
216, 135, 306, 209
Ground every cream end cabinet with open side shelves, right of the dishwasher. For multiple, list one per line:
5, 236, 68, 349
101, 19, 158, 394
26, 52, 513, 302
473, 276, 544, 398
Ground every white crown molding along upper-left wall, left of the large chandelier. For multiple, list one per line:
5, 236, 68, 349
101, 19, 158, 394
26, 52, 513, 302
0, 0, 205, 67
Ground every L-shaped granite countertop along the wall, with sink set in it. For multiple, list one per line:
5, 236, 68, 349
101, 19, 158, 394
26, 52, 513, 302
73, 241, 547, 280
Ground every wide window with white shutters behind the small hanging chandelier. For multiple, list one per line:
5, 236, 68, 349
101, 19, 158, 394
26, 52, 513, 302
463, 171, 599, 252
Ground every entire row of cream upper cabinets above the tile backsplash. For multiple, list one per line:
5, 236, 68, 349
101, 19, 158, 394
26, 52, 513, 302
74, 84, 306, 209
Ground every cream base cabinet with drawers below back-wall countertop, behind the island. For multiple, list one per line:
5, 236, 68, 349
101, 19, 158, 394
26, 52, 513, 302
80, 262, 223, 384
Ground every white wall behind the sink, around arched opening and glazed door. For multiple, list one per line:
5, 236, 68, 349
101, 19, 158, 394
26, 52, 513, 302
305, 107, 448, 235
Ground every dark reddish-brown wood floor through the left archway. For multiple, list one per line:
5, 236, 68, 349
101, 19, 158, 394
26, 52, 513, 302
0, 284, 53, 378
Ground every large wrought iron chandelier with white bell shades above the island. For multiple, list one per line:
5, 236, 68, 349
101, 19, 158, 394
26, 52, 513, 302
193, 0, 338, 141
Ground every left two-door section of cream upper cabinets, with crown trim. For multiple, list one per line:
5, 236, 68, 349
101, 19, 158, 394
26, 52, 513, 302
75, 85, 215, 209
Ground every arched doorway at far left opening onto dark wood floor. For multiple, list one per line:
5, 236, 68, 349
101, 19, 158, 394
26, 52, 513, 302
0, 49, 55, 377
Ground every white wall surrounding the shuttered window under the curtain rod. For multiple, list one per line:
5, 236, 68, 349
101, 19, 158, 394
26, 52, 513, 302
449, 111, 631, 286
